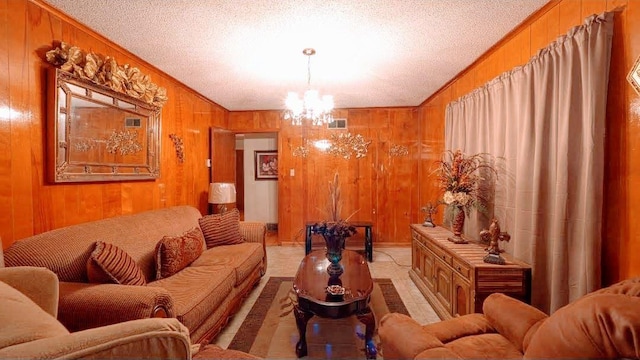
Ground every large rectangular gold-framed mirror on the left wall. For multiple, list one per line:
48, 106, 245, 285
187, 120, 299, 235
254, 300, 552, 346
47, 69, 160, 183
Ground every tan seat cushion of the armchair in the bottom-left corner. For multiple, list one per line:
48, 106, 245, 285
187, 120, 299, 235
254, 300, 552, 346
0, 281, 69, 349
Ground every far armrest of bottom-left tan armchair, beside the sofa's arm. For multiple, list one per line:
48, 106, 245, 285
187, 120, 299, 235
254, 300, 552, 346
0, 266, 58, 317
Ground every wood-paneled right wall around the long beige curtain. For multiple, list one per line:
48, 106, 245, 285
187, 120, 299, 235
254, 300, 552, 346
419, 0, 640, 284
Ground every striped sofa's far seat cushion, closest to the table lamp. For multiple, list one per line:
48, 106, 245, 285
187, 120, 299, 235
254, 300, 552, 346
191, 243, 264, 286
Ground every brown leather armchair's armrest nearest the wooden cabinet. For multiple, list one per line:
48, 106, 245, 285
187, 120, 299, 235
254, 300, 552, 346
482, 293, 548, 352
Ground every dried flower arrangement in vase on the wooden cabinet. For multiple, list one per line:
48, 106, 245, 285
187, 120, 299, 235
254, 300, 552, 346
435, 150, 497, 243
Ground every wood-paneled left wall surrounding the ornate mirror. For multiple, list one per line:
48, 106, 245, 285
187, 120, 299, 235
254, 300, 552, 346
0, 0, 228, 248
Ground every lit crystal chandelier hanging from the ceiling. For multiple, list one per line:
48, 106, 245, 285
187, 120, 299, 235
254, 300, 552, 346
284, 48, 333, 125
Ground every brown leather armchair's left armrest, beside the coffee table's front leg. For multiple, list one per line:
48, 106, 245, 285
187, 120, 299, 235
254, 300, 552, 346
378, 313, 443, 359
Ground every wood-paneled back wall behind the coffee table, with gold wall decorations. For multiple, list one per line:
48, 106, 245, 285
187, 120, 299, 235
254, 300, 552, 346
229, 107, 421, 244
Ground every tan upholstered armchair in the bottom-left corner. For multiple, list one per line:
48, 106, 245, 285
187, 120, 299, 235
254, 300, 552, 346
0, 266, 256, 360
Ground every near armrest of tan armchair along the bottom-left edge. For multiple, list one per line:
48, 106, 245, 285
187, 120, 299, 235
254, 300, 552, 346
0, 319, 191, 359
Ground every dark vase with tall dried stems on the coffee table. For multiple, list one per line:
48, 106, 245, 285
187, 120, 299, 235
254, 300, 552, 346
311, 173, 356, 276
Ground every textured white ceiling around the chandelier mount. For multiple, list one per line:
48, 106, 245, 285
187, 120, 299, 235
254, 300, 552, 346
47, 0, 548, 110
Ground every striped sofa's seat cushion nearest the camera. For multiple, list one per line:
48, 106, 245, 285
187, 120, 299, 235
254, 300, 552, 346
147, 266, 235, 329
